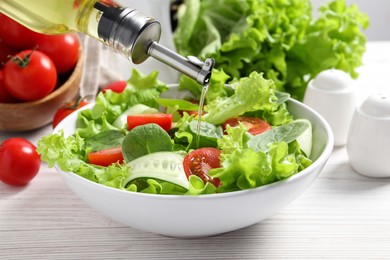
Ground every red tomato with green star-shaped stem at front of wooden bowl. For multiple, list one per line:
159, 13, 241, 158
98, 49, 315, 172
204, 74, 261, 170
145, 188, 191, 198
3, 50, 57, 101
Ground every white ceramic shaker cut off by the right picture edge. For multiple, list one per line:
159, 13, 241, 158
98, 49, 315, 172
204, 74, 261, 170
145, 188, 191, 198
347, 93, 390, 177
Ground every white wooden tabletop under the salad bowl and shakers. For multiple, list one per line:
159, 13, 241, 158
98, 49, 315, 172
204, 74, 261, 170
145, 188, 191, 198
0, 42, 390, 260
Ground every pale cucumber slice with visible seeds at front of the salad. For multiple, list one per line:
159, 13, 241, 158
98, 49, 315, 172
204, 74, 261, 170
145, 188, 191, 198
125, 152, 189, 190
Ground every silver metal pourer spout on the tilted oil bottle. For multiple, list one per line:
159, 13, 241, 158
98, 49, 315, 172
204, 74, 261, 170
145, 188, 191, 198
94, 2, 214, 85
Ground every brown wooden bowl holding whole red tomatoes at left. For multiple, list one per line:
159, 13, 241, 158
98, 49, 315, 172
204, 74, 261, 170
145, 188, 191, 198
0, 49, 83, 132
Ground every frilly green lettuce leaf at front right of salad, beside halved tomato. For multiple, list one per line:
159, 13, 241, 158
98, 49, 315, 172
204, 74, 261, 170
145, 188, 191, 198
209, 141, 312, 192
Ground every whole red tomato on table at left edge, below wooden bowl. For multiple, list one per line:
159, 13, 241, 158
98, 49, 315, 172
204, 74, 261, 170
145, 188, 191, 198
0, 138, 41, 186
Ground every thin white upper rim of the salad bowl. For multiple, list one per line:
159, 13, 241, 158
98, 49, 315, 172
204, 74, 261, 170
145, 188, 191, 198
53, 94, 334, 200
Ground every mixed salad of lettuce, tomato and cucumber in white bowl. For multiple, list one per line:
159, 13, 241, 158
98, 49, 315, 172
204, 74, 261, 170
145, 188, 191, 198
37, 70, 312, 195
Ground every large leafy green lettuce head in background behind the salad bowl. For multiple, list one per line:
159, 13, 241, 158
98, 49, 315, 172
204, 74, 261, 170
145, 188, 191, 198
174, 0, 369, 100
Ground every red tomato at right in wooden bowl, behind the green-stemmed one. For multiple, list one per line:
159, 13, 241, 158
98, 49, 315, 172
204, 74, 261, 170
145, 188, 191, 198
35, 33, 80, 74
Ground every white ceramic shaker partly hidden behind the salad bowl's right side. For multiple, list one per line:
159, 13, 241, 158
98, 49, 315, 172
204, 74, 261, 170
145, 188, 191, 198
303, 69, 357, 146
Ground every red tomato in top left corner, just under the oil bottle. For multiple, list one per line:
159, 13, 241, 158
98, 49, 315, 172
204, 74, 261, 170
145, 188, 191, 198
0, 13, 37, 50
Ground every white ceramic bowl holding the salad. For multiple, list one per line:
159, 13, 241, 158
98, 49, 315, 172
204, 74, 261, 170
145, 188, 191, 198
55, 87, 333, 238
